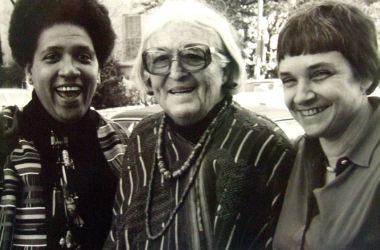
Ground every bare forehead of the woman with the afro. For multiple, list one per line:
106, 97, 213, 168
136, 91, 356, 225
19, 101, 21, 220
37, 24, 94, 50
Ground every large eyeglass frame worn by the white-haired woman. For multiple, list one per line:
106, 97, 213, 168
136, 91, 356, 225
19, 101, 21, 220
141, 43, 230, 76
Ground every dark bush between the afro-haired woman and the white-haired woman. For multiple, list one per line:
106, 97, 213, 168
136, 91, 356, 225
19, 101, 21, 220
92, 59, 141, 109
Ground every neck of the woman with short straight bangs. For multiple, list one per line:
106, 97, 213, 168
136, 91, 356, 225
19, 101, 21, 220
319, 98, 372, 166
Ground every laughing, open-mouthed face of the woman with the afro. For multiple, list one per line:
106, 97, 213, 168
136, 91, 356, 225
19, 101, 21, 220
27, 24, 99, 123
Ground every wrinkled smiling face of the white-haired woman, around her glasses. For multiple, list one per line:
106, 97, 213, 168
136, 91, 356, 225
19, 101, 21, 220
147, 23, 224, 125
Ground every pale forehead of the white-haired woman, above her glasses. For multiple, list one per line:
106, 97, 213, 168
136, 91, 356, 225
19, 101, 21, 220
147, 22, 223, 49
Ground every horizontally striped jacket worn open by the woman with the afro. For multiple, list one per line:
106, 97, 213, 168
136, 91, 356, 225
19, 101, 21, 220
0, 115, 126, 250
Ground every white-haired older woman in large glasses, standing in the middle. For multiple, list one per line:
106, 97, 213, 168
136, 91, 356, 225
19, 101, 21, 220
107, 1, 294, 249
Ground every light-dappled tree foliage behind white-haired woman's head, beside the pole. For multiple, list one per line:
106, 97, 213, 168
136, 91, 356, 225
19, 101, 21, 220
137, 0, 296, 77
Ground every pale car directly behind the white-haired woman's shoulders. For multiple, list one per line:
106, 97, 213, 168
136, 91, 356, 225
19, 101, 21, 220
112, 95, 304, 141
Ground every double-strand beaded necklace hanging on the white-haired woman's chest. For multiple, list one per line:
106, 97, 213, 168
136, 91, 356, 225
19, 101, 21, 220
145, 100, 230, 240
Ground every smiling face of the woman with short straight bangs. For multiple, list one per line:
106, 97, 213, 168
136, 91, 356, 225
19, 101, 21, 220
279, 51, 367, 138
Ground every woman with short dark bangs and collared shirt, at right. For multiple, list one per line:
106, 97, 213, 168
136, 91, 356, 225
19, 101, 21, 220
273, 1, 380, 250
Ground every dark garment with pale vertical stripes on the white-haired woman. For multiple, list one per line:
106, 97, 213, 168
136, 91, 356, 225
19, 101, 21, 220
105, 104, 294, 250
